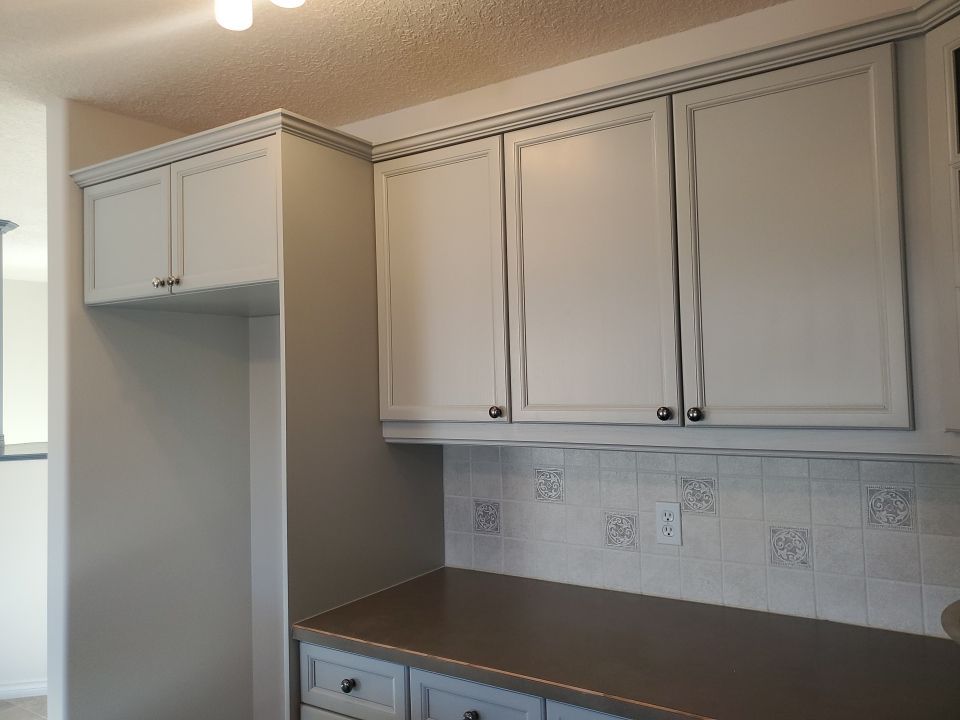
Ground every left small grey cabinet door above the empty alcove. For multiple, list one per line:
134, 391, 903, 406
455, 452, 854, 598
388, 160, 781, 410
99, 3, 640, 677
83, 167, 170, 304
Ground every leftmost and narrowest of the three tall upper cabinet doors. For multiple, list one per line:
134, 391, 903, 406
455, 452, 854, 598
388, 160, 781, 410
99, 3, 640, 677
375, 138, 509, 422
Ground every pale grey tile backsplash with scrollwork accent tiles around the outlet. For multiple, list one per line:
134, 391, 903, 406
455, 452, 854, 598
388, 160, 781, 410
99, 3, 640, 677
443, 446, 960, 636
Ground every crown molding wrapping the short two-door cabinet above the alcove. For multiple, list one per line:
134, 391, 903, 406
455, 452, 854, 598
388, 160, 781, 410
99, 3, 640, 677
70, 108, 372, 188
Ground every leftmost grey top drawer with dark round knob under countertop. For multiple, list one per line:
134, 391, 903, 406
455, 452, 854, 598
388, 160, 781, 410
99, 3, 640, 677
300, 643, 407, 720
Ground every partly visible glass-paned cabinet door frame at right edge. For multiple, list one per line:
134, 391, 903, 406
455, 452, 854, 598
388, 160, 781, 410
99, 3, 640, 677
925, 18, 960, 432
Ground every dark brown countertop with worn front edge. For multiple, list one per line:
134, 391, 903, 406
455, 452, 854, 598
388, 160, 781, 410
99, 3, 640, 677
293, 568, 960, 720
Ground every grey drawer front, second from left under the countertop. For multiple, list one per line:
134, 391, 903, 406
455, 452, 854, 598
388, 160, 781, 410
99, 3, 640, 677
410, 669, 543, 720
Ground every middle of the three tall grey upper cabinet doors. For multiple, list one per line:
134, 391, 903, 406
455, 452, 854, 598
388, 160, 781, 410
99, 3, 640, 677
504, 99, 678, 424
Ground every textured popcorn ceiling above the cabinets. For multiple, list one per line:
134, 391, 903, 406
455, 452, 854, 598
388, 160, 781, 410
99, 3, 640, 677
0, 0, 784, 131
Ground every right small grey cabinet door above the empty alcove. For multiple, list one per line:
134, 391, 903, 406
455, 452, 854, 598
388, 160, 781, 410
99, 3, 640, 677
171, 136, 280, 292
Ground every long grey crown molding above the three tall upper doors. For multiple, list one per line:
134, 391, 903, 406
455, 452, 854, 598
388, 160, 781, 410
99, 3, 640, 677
373, 0, 960, 162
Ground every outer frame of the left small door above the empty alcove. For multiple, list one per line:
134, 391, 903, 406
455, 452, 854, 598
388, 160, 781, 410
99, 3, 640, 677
83, 166, 171, 305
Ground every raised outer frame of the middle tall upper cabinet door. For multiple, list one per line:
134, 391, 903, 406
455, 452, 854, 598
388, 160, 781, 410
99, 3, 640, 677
504, 98, 682, 426
